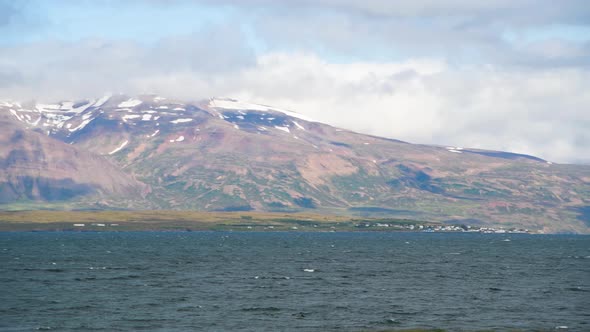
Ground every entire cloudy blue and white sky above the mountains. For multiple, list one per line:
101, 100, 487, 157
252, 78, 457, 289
0, 0, 590, 164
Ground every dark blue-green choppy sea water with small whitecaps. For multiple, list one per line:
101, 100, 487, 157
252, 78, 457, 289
0, 232, 590, 331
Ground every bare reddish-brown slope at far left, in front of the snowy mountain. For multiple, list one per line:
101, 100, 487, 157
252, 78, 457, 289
0, 107, 147, 203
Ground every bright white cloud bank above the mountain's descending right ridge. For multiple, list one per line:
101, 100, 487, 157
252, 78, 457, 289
222, 55, 590, 162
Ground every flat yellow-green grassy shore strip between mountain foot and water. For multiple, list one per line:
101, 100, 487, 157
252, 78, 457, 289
0, 210, 438, 231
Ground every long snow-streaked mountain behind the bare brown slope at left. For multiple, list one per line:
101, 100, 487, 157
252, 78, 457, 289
0, 95, 590, 233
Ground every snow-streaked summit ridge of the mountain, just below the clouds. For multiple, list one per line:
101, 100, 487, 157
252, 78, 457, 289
0, 96, 312, 140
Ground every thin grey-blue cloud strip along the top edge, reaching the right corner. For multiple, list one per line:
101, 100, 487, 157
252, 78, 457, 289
195, 0, 590, 26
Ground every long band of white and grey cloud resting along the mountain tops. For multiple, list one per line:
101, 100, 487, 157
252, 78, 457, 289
0, 38, 590, 162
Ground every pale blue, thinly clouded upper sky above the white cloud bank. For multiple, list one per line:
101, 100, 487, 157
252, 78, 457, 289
0, 0, 590, 67
